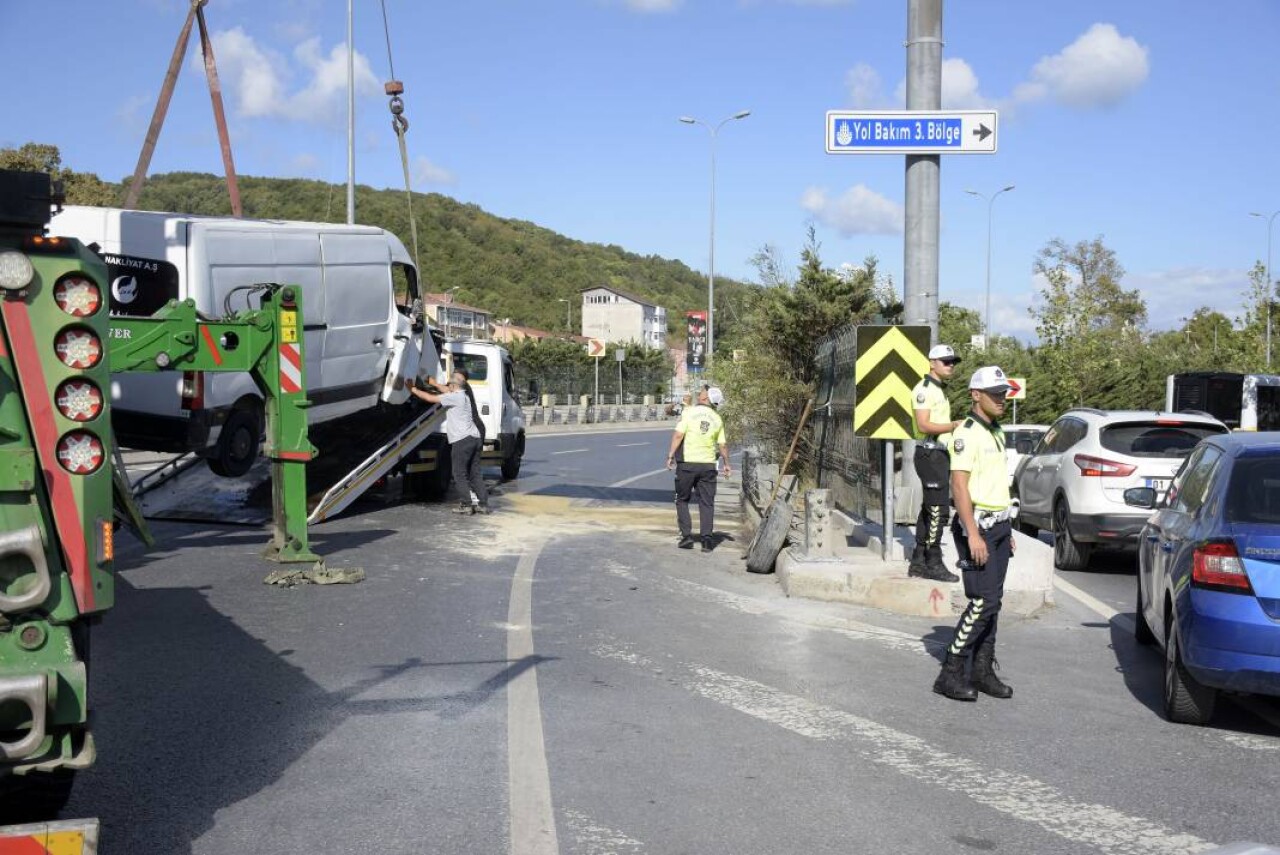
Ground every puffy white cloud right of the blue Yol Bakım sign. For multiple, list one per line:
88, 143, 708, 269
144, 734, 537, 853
1014, 23, 1151, 109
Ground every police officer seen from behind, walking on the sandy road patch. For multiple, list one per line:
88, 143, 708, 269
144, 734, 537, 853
667, 387, 731, 552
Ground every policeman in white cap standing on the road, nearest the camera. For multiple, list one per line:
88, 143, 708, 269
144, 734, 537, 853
933, 365, 1014, 700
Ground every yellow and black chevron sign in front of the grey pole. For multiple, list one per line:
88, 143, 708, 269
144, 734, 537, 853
854, 326, 931, 439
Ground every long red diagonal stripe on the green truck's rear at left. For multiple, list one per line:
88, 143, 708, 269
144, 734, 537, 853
0, 300, 93, 606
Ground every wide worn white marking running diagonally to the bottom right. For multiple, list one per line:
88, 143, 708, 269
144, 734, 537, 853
591, 644, 1213, 855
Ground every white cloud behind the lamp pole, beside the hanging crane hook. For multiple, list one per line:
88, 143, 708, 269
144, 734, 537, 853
214, 27, 381, 124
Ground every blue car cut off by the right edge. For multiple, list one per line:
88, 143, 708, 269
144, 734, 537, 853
1125, 433, 1280, 724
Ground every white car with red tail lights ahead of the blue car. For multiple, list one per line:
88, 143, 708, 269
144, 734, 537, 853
1012, 408, 1228, 570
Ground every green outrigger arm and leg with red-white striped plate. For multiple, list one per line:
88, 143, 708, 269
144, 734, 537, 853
108, 290, 321, 563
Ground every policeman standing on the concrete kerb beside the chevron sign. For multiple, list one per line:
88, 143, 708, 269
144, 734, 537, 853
906, 344, 960, 582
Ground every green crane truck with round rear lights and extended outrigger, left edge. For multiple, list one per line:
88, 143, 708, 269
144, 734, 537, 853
0, 170, 348, 852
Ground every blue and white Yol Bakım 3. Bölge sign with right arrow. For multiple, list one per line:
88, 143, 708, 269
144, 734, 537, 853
827, 110, 998, 155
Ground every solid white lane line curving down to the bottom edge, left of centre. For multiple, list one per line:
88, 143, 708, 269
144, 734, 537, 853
507, 540, 559, 855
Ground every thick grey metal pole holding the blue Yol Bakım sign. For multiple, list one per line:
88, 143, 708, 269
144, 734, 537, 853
902, 0, 942, 342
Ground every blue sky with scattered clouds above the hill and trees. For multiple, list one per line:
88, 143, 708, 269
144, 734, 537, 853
0, 0, 1280, 340
